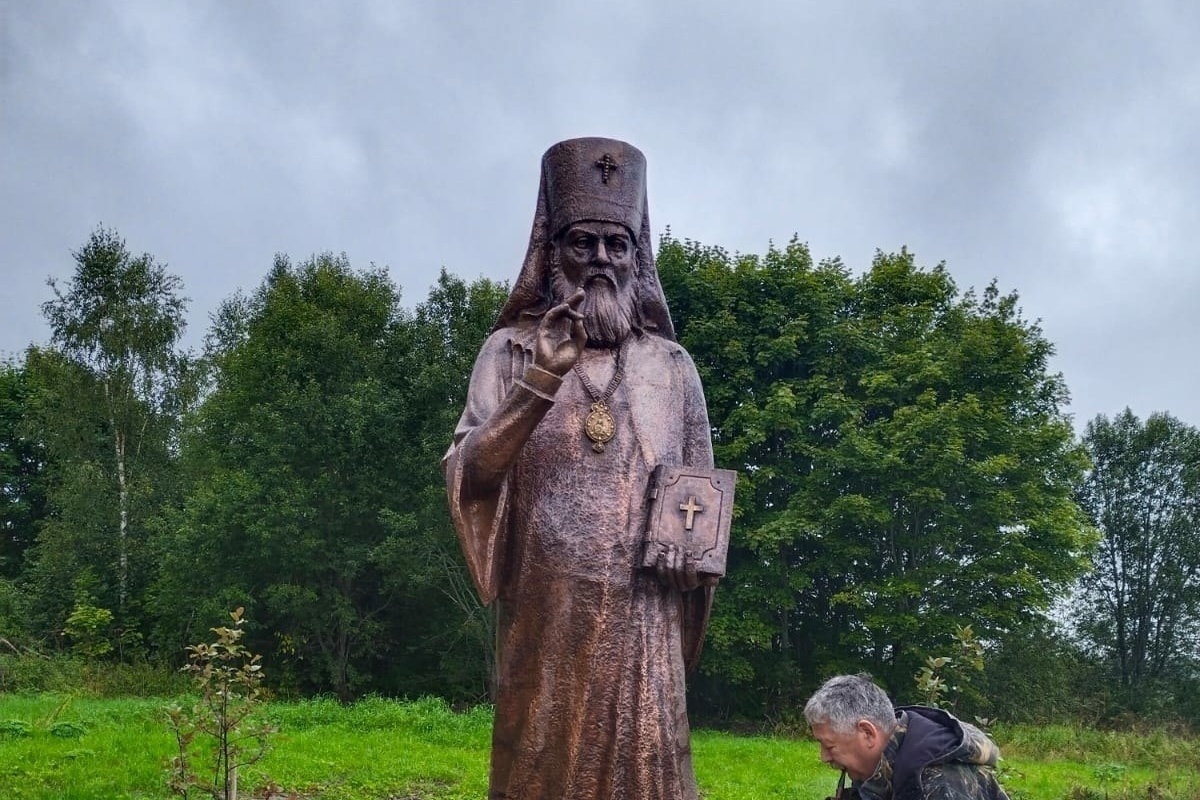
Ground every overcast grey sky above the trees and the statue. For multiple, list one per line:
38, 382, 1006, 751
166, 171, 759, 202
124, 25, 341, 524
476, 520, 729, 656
0, 0, 1200, 427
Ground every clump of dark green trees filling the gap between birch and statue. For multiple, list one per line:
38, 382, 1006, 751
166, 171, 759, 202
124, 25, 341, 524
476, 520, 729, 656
152, 254, 506, 700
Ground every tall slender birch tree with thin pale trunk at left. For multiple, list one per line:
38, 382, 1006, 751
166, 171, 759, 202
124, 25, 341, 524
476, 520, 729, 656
20, 228, 191, 657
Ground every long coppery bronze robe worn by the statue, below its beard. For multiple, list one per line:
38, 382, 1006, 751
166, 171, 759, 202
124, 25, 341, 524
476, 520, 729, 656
444, 329, 713, 800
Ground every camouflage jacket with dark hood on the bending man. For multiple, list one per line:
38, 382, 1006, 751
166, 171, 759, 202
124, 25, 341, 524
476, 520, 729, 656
847, 705, 1008, 800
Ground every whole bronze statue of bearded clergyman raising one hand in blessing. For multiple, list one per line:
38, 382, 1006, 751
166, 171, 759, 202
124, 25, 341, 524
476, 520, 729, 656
443, 139, 732, 800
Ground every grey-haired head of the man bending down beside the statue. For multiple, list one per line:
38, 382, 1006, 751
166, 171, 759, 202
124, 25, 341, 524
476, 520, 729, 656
804, 675, 896, 781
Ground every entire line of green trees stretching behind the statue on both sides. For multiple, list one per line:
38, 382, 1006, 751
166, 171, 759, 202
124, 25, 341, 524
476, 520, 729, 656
0, 228, 1200, 723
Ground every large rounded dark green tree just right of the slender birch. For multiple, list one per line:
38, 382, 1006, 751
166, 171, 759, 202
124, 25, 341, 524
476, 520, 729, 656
156, 255, 408, 698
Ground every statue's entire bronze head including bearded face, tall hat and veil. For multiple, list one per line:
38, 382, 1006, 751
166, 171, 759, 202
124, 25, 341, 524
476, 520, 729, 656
487, 138, 674, 347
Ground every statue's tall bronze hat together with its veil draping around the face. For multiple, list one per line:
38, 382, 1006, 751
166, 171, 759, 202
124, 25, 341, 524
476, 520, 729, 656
496, 138, 674, 339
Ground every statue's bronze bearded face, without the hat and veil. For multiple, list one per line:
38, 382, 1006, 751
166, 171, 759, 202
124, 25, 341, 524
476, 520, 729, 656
551, 219, 637, 347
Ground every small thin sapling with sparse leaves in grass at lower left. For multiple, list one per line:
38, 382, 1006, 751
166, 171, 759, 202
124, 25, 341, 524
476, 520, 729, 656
167, 608, 274, 800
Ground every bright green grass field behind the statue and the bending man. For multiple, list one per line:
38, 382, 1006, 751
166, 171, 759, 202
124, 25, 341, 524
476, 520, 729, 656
0, 694, 1200, 800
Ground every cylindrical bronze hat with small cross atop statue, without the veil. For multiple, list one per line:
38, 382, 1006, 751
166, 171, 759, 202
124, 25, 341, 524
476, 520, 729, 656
541, 138, 646, 239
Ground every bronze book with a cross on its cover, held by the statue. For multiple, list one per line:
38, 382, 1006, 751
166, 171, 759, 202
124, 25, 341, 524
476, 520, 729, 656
642, 464, 738, 577
